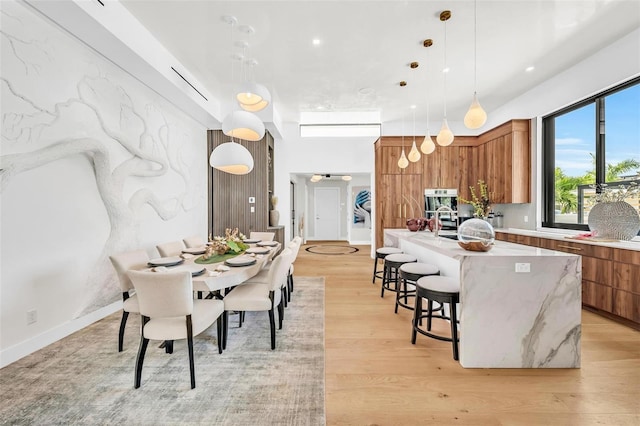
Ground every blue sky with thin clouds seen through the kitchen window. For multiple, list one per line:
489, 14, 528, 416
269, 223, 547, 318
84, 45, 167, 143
555, 84, 640, 176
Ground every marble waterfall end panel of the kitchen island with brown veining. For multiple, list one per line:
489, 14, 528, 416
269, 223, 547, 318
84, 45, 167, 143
460, 256, 582, 368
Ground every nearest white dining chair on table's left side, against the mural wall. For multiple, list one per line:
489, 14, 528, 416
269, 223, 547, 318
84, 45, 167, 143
109, 250, 149, 352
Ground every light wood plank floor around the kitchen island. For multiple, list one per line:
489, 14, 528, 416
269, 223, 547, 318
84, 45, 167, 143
294, 242, 640, 426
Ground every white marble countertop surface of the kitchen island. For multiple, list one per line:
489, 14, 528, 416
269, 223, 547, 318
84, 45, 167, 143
385, 229, 577, 259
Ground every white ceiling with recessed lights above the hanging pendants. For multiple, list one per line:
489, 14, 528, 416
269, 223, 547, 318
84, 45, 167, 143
120, 0, 640, 130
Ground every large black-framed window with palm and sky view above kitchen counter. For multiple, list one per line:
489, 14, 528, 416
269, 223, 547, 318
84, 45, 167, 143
542, 78, 640, 229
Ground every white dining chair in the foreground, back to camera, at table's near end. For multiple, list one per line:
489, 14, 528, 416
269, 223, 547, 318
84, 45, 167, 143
128, 271, 224, 389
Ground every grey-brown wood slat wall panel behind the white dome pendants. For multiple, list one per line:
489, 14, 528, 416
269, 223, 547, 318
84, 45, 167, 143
207, 130, 273, 241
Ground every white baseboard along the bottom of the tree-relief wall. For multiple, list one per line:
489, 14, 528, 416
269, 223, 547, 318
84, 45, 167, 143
0, 301, 122, 368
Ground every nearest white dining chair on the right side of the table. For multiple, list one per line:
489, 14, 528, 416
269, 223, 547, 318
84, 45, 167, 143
223, 249, 292, 350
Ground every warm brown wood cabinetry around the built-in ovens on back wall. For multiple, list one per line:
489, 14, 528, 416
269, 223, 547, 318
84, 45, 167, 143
375, 120, 531, 247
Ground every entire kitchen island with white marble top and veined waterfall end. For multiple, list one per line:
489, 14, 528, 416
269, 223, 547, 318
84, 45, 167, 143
384, 229, 582, 368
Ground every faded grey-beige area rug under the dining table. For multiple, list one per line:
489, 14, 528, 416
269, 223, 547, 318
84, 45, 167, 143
0, 277, 325, 425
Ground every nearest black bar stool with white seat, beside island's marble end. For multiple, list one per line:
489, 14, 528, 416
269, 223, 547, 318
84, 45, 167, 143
411, 275, 460, 361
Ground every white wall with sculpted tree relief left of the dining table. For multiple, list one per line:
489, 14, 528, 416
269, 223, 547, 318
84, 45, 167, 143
0, 1, 207, 366
